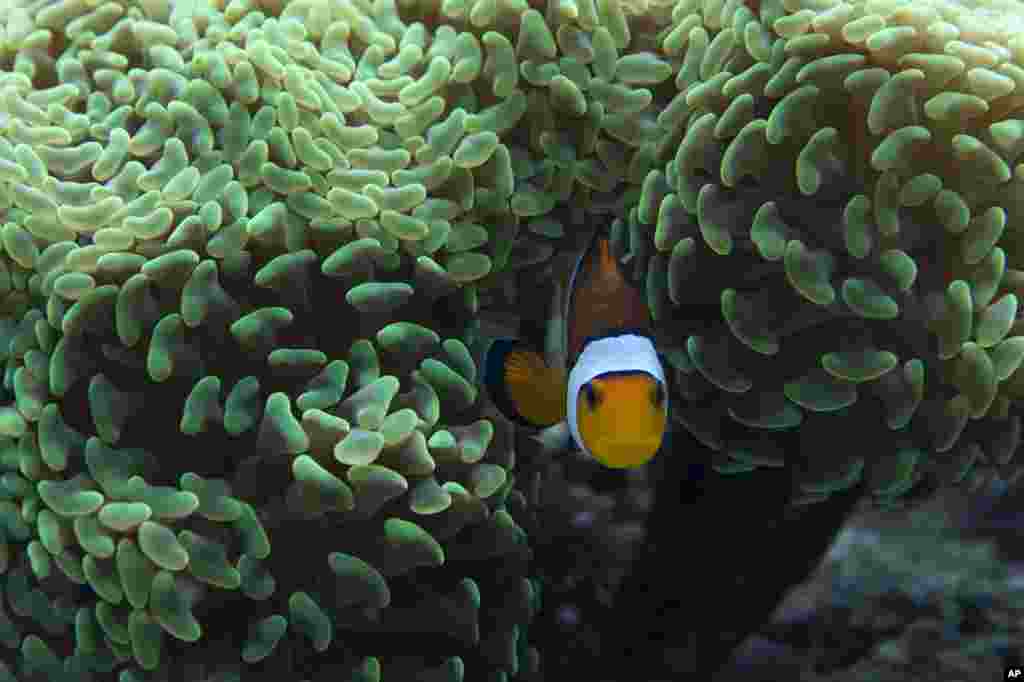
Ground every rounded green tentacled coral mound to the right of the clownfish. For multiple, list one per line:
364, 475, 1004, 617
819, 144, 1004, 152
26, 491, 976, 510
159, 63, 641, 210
638, 2, 1024, 505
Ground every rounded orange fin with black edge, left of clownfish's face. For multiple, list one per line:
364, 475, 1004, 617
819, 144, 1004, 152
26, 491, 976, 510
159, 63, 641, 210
483, 339, 566, 428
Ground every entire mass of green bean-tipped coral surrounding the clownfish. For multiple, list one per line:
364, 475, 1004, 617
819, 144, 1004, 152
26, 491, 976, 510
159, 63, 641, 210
0, 0, 1024, 680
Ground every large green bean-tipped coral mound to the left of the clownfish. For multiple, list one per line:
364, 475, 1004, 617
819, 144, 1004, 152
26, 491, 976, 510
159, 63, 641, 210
0, 1, 552, 680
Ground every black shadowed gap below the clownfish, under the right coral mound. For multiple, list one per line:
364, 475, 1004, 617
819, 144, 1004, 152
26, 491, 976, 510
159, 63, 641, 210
599, 425, 862, 682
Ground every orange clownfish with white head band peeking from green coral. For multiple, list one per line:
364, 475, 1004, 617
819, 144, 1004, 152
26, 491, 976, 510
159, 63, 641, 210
482, 228, 669, 469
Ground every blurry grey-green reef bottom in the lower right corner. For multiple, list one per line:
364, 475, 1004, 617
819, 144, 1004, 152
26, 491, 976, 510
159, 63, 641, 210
764, 491, 1024, 682
